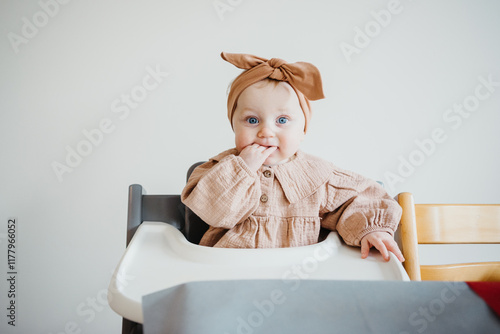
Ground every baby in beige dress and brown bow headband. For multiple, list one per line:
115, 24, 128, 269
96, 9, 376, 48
181, 52, 404, 261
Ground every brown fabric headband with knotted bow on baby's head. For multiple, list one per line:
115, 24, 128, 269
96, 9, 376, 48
221, 52, 324, 131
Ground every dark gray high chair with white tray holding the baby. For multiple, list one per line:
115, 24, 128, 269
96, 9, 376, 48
112, 162, 409, 334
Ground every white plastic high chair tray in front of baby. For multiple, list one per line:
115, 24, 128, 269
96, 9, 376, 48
108, 222, 409, 323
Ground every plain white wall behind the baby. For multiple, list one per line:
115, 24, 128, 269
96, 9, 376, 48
0, 0, 500, 334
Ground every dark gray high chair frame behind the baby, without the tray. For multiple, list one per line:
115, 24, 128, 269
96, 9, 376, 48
122, 162, 208, 334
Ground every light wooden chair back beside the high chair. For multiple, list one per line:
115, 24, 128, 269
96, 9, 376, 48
398, 192, 500, 281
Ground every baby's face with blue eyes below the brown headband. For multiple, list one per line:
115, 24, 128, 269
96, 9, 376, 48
232, 81, 305, 166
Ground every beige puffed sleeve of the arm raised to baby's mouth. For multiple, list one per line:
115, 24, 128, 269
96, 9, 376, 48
181, 154, 261, 229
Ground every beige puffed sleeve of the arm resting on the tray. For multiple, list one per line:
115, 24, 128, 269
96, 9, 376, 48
321, 169, 402, 246
